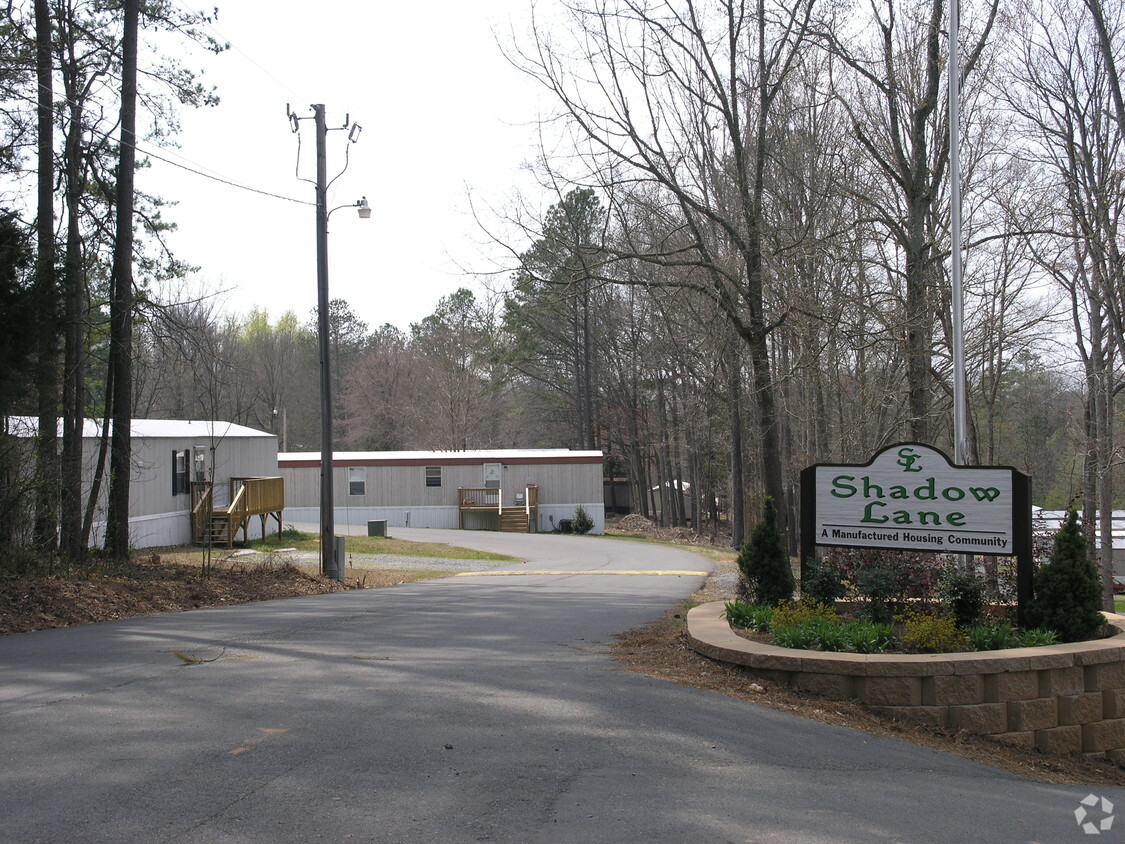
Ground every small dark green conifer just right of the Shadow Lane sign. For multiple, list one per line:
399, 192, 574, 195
1027, 509, 1105, 641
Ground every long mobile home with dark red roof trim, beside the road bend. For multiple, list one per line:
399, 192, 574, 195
278, 449, 605, 533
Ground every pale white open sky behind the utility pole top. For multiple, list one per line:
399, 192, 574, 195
145, 0, 541, 330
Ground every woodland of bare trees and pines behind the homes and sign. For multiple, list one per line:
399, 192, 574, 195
0, 0, 1125, 585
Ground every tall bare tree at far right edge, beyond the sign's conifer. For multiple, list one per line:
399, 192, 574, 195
1006, 0, 1125, 609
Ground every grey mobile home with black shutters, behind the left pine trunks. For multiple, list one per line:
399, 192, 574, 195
9, 416, 284, 548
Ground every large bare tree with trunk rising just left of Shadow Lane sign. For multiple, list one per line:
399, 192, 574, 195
518, 0, 815, 542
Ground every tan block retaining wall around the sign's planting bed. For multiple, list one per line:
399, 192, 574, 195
687, 602, 1125, 766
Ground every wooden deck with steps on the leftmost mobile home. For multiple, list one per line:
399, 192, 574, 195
191, 477, 285, 548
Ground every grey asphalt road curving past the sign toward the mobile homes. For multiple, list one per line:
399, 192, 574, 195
0, 530, 1125, 843
